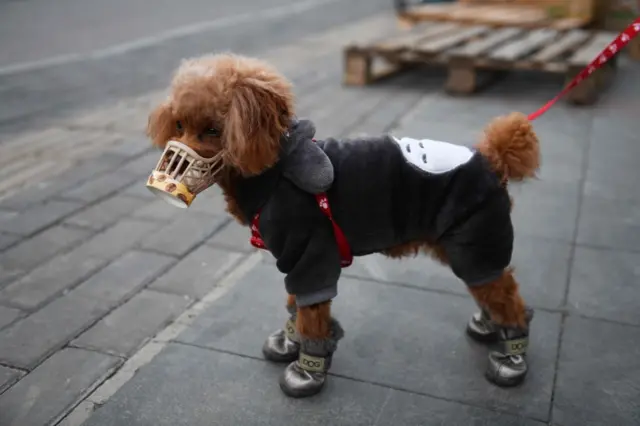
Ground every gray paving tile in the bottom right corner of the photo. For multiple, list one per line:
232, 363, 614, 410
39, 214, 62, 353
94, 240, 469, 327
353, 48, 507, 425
553, 316, 640, 426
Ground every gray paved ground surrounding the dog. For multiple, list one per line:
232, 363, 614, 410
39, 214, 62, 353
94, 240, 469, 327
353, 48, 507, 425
0, 0, 640, 426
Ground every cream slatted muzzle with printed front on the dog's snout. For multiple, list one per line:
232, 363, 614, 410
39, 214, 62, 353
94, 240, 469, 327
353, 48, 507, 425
147, 141, 223, 208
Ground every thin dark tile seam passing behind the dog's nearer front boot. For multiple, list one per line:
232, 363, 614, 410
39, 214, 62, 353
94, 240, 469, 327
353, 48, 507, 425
170, 339, 547, 424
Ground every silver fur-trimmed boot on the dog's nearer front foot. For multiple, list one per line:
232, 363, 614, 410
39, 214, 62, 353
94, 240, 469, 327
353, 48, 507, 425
280, 319, 344, 398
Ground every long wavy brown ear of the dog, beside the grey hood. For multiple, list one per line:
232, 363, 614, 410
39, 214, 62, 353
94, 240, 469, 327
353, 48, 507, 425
223, 78, 292, 176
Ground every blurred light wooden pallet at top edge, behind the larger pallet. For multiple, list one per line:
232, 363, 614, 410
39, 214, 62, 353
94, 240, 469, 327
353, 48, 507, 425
398, 3, 592, 30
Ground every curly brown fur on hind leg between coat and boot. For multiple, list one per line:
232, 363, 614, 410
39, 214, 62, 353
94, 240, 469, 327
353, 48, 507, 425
469, 269, 527, 329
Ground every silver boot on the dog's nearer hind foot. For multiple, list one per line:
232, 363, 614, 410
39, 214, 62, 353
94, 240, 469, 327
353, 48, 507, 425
486, 310, 533, 387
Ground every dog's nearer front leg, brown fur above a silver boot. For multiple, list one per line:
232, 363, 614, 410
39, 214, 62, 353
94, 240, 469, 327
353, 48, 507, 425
280, 301, 344, 398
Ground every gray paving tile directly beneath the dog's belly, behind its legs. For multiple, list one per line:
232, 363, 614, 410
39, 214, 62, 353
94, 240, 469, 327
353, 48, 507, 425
179, 265, 560, 421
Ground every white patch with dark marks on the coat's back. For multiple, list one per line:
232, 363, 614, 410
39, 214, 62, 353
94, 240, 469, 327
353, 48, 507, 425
393, 136, 473, 174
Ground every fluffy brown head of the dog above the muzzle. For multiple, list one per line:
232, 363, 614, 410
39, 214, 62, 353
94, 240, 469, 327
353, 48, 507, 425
147, 54, 294, 176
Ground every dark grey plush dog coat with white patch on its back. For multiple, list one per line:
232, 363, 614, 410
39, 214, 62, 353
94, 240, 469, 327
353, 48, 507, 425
236, 120, 513, 306
